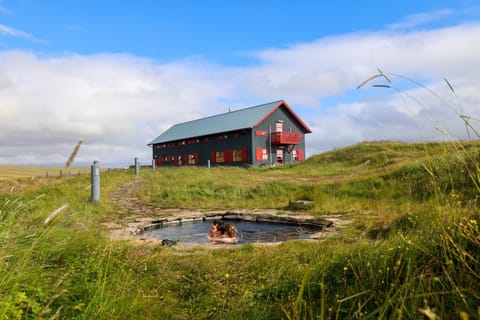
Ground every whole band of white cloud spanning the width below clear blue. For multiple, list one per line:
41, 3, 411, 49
0, 24, 480, 165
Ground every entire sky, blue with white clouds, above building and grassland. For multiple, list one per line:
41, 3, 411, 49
0, 0, 480, 167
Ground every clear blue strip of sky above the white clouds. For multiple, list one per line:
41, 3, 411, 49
2, 0, 479, 65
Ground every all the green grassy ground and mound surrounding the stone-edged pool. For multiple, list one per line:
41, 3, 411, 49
0, 141, 480, 319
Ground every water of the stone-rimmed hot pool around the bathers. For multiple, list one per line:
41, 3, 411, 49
139, 219, 323, 244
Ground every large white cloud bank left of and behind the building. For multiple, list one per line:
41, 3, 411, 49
0, 51, 231, 163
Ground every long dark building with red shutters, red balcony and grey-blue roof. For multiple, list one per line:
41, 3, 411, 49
148, 100, 311, 167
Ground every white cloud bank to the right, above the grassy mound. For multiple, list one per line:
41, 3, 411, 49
235, 24, 480, 154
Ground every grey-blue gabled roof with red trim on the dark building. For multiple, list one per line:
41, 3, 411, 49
148, 100, 312, 145
